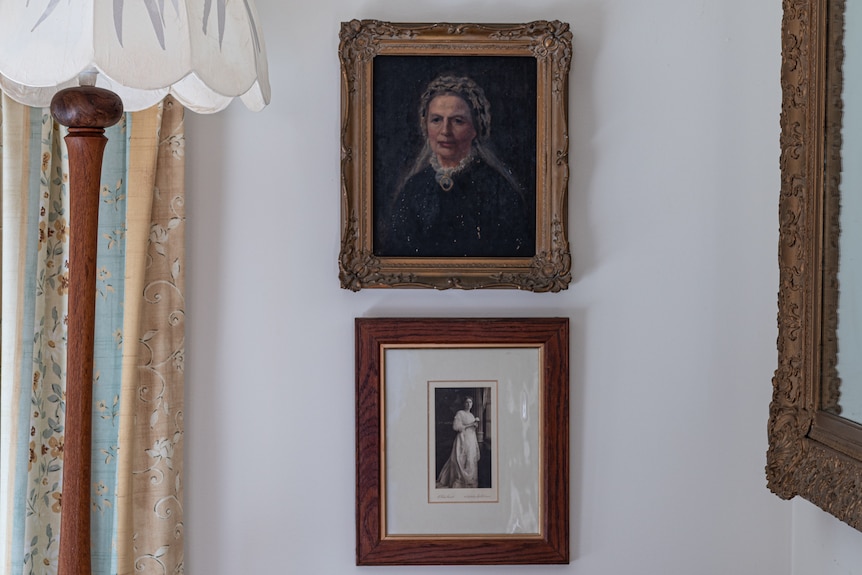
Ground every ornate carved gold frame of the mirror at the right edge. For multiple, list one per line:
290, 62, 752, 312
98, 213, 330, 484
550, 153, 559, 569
766, 0, 862, 529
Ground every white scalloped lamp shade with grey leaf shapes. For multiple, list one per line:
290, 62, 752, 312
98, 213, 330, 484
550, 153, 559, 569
0, 0, 270, 113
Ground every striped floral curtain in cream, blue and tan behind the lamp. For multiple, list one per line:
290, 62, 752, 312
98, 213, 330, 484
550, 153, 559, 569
0, 95, 185, 575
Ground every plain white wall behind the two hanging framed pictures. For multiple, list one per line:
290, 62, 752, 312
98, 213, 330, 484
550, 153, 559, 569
179, 0, 860, 575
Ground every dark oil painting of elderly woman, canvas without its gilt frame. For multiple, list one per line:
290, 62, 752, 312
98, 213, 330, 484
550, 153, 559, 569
374, 56, 536, 258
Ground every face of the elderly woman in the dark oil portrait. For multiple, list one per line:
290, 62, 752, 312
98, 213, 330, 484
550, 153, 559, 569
425, 94, 476, 168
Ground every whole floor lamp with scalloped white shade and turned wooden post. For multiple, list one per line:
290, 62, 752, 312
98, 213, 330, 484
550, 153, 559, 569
0, 0, 269, 575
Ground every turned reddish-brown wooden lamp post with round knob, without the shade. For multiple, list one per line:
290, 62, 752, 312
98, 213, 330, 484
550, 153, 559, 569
51, 86, 123, 575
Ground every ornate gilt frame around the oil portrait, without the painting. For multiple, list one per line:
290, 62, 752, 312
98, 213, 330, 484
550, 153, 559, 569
338, 20, 572, 292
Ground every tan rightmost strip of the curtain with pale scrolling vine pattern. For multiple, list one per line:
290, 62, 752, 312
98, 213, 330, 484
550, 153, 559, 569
126, 98, 185, 573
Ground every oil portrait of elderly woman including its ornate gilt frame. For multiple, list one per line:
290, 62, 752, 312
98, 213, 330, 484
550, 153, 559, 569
339, 20, 572, 292
